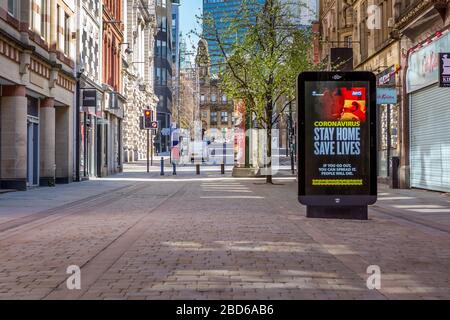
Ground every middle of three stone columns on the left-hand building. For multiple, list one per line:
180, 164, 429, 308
39, 98, 56, 186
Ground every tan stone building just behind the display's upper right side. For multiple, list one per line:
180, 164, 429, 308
353, 0, 401, 181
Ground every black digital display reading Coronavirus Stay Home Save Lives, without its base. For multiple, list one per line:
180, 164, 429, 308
298, 72, 377, 206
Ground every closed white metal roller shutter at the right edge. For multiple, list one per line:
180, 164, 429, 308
410, 85, 450, 192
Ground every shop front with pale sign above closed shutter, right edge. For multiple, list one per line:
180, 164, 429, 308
406, 29, 450, 192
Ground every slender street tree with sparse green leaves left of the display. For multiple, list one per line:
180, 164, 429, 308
203, 0, 314, 183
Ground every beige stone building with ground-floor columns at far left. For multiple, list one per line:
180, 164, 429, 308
0, 0, 76, 190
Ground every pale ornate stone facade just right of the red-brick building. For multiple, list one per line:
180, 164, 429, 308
123, 0, 158, 162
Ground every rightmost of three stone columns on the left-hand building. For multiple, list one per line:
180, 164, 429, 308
55, 106, 73, 183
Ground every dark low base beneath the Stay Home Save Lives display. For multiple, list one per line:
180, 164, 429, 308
306, 206, 368, 220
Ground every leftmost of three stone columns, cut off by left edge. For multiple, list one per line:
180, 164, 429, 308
0, 85, 27, 190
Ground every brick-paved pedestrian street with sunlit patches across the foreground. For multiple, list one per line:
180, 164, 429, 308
0, 162, 450, 299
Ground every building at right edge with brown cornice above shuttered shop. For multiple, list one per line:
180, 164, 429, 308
391, 0, 450, 192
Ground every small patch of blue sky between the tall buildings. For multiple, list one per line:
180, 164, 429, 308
180, 0, 203, 56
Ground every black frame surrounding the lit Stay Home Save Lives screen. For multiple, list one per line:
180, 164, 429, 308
297, 71, 378, 207
